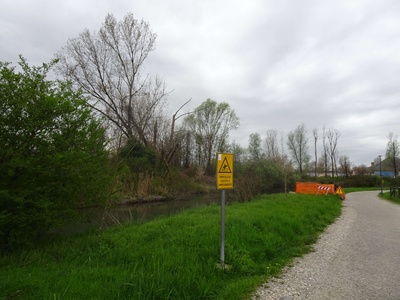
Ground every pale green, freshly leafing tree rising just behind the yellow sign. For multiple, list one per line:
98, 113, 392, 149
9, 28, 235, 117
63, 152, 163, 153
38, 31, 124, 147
184, 99, 239, 174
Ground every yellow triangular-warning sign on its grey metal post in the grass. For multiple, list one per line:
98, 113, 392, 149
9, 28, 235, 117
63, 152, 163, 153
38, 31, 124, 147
217, 153, 233, 269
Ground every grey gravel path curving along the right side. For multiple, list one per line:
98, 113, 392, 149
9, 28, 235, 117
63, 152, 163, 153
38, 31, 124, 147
253, 191, 400, 300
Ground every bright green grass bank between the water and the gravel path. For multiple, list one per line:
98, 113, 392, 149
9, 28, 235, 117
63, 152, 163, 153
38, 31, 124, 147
0, 194, 341, 299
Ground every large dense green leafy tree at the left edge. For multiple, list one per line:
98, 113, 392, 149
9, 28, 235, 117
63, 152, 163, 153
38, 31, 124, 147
0, 57, 110, 250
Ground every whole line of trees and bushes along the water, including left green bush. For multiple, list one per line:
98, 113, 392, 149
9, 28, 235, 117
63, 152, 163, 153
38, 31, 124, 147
0, 14, 382, 251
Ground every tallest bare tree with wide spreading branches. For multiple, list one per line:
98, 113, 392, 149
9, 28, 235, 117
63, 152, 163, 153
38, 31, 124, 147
57, 13, 166, 146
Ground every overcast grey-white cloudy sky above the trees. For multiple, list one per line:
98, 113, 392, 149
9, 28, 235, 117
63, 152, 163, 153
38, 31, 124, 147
0, 0, 400, 166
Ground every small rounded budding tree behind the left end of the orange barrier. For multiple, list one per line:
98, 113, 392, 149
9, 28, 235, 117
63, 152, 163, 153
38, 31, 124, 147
287, 124, 310, 174
